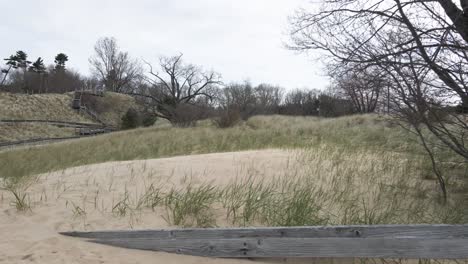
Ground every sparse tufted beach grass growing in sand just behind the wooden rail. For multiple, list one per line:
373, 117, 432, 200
59, 144, 468, 227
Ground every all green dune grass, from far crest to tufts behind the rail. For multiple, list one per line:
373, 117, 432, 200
0, 115, 468, 230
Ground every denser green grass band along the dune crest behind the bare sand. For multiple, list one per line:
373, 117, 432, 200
0, 115, 444, 177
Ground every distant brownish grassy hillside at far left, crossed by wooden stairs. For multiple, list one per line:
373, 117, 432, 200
0, 93, 136, 142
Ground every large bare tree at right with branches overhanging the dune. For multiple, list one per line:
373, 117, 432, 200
290, 0, 468, 198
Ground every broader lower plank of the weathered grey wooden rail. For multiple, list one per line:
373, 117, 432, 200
91, 238, 468, 259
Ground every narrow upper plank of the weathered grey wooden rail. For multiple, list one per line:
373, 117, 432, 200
61, 225, 468, 239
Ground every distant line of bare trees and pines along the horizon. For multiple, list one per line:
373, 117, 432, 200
0, 37, 383, 126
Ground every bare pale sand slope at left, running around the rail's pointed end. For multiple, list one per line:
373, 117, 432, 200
0, 150, 348, 264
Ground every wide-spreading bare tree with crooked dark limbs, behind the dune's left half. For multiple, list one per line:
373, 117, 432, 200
133, 54, 221, 125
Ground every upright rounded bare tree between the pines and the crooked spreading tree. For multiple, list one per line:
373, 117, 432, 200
89, 37, 142, 93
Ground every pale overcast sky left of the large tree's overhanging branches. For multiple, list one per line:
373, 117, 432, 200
0, 0, 328, 89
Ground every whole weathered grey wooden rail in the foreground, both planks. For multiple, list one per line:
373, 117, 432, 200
62, 225, 468, 259
